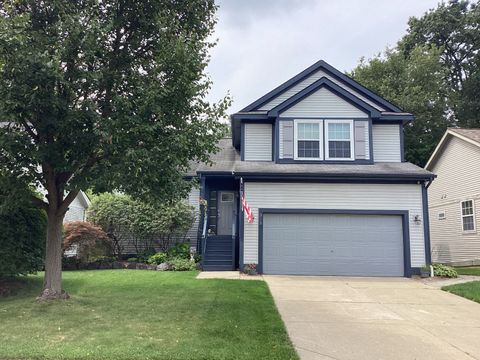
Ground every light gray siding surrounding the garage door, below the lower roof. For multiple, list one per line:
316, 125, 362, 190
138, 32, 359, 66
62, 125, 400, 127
243, 182, 425, 267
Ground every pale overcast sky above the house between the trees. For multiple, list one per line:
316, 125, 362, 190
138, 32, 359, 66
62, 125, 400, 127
208, 0, 438, 113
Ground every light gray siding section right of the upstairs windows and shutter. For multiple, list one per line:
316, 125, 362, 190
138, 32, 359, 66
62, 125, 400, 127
372, 124, 402, 162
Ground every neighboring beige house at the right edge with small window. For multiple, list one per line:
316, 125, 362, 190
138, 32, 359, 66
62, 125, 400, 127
425, 129, 480, 265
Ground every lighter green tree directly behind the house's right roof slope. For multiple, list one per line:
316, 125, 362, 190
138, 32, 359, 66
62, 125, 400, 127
351, 47, 448, 166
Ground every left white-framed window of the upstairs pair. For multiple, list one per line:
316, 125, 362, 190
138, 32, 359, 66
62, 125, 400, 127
295, 120, 323, 160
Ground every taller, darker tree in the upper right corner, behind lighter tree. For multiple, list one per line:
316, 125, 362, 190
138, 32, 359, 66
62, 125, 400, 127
398, 0, 480, 127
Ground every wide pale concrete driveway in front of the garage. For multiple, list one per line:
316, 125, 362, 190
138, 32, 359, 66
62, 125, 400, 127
264, 276, 480, 360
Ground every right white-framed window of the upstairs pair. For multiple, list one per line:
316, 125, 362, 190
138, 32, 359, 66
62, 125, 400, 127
325, 120, 354, 160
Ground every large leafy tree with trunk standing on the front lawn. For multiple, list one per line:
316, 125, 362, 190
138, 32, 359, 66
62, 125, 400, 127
0, 0, 229, 299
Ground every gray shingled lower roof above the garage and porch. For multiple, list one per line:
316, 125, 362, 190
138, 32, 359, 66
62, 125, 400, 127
189, 139, 434, 179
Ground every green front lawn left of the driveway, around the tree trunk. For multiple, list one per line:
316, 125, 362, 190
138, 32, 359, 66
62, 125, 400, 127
0, 270, 298, 360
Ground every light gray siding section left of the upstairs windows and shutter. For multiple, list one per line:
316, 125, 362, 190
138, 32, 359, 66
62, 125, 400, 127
244, 124, 273, 161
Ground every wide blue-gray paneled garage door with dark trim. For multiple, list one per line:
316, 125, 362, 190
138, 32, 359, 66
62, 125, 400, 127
262, 213, 404, 276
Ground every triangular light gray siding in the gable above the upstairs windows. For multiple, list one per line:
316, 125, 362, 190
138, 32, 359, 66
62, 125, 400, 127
281, 88, 368, 118
